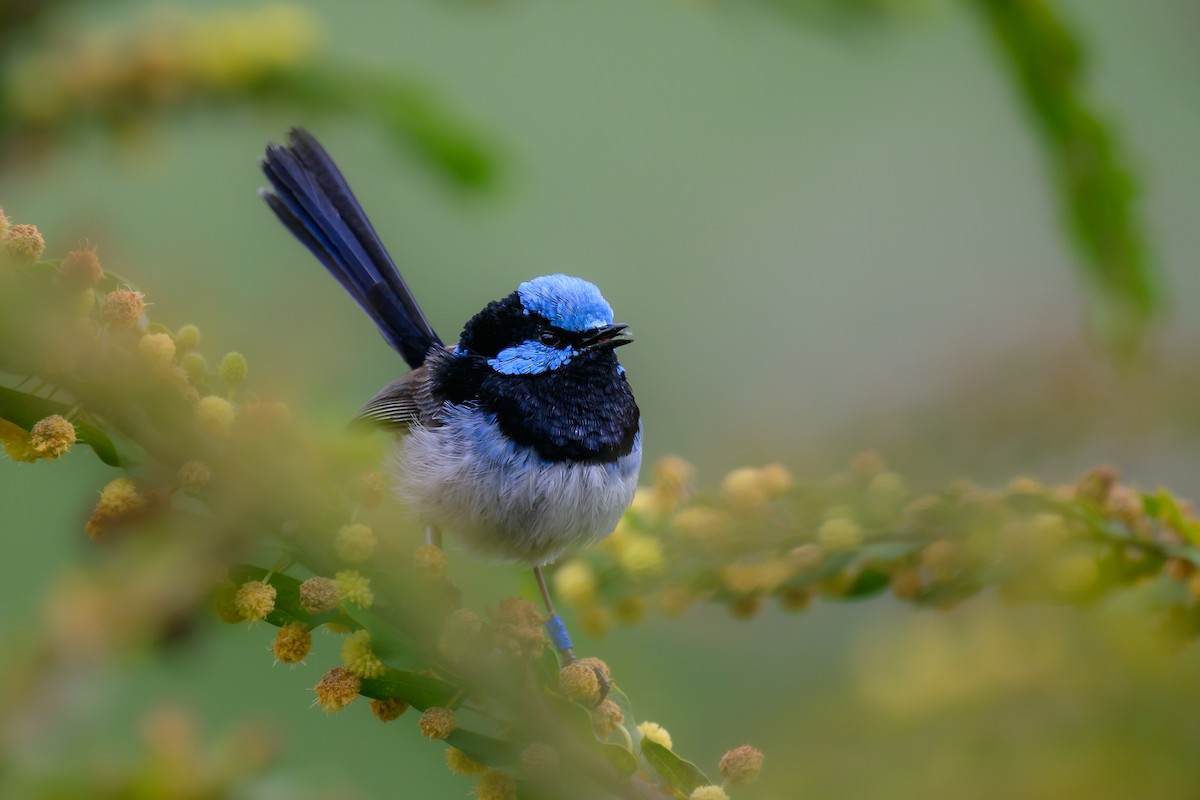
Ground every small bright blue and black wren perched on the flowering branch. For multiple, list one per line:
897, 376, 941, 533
260, 128, 642, 660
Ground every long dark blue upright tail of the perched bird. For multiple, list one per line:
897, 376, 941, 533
259, 128, 442, 368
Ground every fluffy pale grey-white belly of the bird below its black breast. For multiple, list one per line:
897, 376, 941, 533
396, 407, 642, 564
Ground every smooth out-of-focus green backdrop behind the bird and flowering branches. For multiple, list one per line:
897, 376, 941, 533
0, 0, 1200, 799
